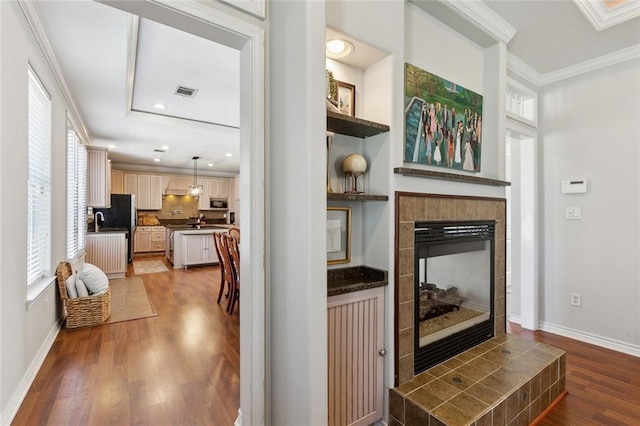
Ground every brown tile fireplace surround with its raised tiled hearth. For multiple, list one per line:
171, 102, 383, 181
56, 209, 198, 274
396, 192, 566, 426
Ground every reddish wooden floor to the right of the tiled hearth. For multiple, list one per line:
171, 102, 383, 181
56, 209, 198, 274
509, 324, 640, 426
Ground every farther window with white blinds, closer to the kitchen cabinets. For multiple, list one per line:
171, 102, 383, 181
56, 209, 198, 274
67, 121, 87, 260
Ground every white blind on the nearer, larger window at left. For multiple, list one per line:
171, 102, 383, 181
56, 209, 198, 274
27, 69, 51, 285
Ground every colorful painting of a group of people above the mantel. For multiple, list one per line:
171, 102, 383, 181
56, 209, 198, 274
404, 63, 482, 172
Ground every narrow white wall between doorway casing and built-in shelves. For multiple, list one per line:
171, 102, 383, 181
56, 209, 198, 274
267, 1, 328, 425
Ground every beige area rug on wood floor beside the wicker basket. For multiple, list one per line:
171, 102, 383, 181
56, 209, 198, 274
105, 277, 158, 324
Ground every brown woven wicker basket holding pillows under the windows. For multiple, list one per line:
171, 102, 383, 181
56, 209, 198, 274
56, 262, 111, 328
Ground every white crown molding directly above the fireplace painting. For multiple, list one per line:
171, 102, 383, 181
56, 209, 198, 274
442, 0, 517, 44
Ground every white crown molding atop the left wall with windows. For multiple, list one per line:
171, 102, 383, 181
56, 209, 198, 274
18, 0, 92, 145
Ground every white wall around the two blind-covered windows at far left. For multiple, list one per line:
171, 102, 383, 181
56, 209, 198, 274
0, 2, 67, 424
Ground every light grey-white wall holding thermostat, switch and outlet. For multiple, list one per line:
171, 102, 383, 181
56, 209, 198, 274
539, 59, 640, 355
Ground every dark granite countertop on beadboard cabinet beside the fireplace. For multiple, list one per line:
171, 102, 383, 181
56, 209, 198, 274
327, 266, 389, 297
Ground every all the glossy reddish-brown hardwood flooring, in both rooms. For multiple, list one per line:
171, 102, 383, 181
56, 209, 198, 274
13, 257, 640, 426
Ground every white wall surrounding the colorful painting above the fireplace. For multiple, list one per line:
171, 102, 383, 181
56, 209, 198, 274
392, 3, 506, 197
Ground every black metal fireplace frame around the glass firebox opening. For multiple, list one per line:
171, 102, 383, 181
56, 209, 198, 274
414, 220, 496, 374
